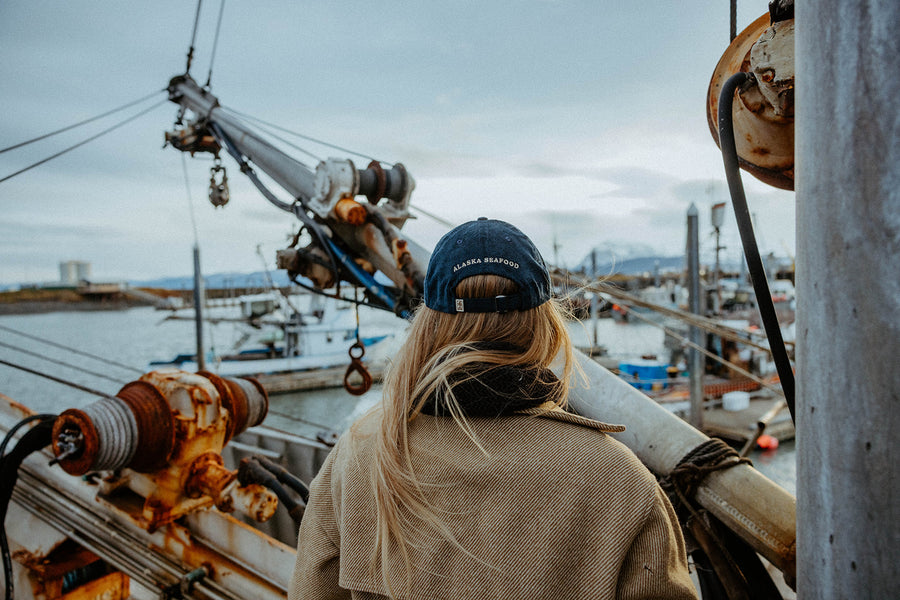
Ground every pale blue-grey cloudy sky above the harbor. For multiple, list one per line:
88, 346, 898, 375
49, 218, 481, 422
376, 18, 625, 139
0, 0, 794, 284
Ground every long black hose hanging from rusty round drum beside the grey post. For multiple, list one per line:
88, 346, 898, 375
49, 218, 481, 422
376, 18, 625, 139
718, 72, 795, 421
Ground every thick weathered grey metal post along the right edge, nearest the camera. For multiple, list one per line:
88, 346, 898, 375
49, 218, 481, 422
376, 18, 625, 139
795, 0, 900, 599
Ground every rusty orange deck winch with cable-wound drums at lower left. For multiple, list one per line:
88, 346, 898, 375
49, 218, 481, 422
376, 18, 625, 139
52, 369, 278, 531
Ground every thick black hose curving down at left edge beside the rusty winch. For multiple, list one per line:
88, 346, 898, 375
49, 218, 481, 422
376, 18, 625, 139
0, 415, 56, 600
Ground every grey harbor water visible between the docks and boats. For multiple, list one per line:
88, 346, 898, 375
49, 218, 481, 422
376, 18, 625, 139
0, 308, 796, 493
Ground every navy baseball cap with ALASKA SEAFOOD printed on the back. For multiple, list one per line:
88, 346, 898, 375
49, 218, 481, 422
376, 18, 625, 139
425, 217, 550, 314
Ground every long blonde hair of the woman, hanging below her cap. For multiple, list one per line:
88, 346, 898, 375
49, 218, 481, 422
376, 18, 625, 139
371, 275, 574, 597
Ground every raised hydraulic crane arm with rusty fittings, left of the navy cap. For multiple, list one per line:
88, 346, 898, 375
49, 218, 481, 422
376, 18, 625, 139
166, 75, 429, 314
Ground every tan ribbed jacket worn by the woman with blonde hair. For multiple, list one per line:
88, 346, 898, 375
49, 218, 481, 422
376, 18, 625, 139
288, 410, 697, 600
